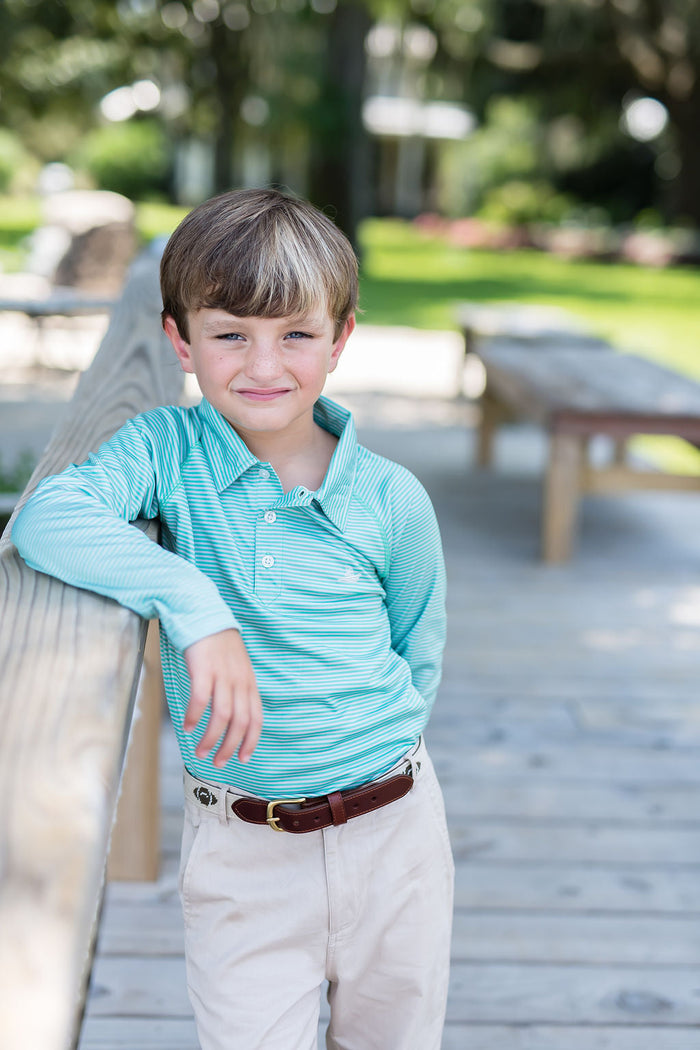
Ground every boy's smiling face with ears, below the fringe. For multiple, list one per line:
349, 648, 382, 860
165, 308, 355, 447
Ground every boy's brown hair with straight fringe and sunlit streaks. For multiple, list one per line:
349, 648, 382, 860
161, 189, 358, 340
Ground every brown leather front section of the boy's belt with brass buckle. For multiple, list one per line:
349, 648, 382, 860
231, 773, 413, 835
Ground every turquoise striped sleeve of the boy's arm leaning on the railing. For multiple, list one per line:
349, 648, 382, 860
12, 421, 238, 651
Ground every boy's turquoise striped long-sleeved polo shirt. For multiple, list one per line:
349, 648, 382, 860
13, 398, 445, 798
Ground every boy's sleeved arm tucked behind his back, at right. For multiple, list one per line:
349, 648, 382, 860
384, 483, 446, 706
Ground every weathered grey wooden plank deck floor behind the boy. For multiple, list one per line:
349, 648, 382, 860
76, 398, 700, 1050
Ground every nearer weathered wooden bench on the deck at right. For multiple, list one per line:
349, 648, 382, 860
476, 333, 700, 562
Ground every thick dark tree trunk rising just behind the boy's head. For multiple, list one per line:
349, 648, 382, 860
310, 0, 372, 248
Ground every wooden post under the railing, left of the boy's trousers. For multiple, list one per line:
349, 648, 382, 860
107, 622, 164, 882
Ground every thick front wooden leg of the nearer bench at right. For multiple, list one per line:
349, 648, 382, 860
542, 432, 586, 563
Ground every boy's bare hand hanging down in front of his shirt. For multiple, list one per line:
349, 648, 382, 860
185, 630, 262, 765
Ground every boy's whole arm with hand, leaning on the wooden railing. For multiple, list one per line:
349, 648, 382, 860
12, 422, 261, 765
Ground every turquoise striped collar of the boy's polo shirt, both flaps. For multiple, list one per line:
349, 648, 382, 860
197, 397, 358, 532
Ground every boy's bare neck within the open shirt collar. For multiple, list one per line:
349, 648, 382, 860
235, 420, 338, 492
